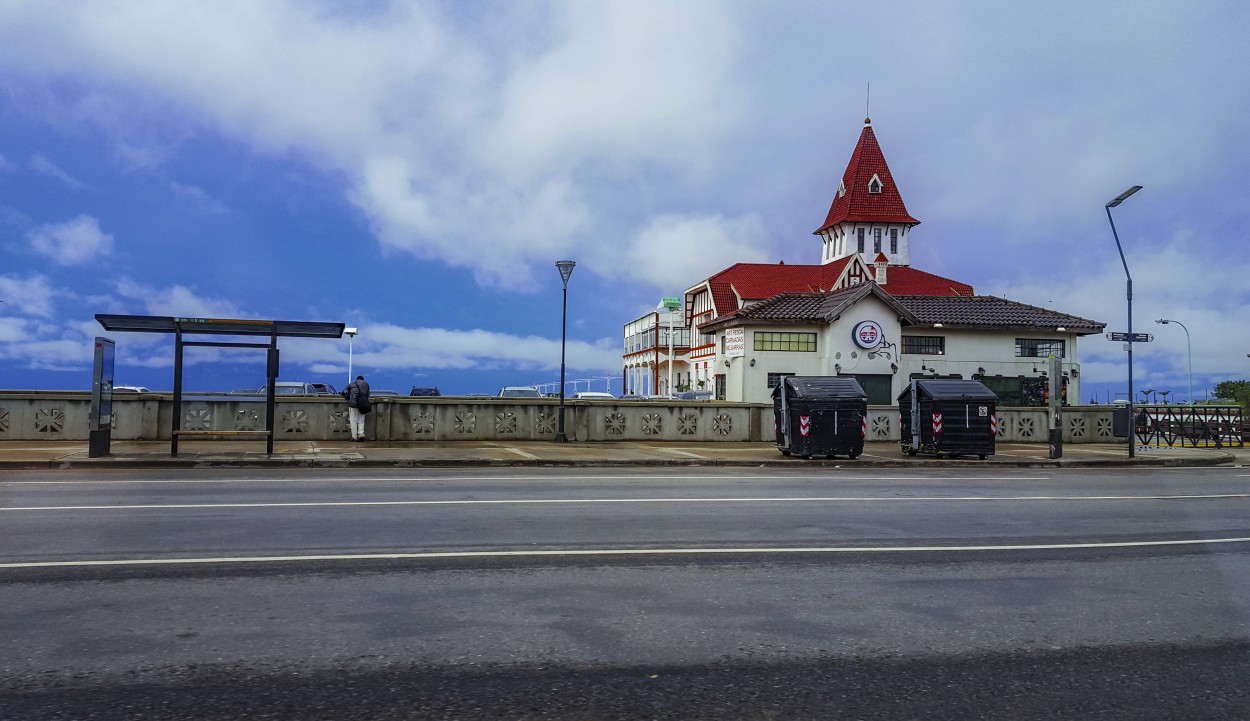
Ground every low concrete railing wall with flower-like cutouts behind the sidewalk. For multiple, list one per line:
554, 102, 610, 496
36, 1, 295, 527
0, 391, 1115, 444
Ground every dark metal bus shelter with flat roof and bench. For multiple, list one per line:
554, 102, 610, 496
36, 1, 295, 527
95, 314, 344, 456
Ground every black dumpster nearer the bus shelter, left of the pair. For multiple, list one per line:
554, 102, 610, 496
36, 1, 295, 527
773, 376, 868, 459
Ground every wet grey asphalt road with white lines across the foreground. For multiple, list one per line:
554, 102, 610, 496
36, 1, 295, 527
0, 469, 1250, 720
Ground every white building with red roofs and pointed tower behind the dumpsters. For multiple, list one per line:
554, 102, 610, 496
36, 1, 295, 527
624, 119, 1103, 405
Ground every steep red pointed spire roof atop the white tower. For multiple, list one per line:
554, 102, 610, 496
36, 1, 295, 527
814, 117, 920, 235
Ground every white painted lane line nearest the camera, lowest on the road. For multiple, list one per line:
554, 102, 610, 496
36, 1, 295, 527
7, 537, 1250, 569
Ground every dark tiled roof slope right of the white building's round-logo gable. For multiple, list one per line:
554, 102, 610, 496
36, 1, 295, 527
891, 294, 1106, 335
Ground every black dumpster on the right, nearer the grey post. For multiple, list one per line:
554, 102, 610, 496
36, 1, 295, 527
899, 379, 999, 461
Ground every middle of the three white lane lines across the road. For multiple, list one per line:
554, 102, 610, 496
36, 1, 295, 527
7, 494, 1250, 512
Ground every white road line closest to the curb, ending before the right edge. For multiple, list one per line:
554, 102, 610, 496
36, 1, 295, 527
0, 472, 1051, 487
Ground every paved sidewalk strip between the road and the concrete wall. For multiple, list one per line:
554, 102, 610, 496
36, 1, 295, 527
0, 440, 1250, 470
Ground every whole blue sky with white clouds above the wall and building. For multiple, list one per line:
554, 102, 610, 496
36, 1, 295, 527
0, 0, 1250, 397
